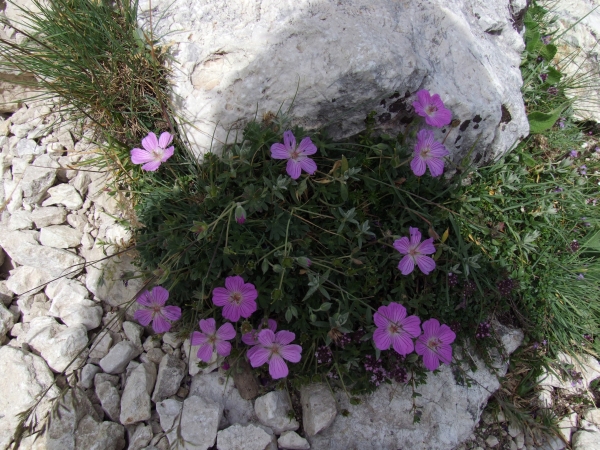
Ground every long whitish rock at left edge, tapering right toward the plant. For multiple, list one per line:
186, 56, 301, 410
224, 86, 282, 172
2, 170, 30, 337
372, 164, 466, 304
0, 230, 85, 278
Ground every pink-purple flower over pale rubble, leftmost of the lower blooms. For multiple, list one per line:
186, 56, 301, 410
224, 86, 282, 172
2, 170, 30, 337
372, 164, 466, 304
133, 286, 181, 333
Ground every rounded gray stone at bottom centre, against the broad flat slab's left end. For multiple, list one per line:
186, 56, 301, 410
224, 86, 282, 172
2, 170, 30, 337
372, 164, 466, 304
300, 383, 337, 436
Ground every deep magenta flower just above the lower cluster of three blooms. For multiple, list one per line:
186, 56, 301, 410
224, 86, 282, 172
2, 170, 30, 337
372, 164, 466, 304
213, 276, 258, 322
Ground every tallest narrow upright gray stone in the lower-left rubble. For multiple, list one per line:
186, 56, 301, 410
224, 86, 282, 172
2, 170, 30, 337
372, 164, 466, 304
117, 362, 156, 425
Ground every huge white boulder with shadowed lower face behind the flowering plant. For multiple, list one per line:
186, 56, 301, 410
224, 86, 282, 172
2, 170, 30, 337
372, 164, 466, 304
140, 0, 529, 161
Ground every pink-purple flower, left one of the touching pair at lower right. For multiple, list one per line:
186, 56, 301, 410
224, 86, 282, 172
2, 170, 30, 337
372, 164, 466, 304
373, 303, 421, 356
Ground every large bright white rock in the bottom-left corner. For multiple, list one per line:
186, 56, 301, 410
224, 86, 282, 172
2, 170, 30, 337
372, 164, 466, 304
0, 346, 58, 449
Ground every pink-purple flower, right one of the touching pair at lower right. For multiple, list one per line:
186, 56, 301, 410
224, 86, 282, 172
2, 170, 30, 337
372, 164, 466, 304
415, 319, 456, 370
